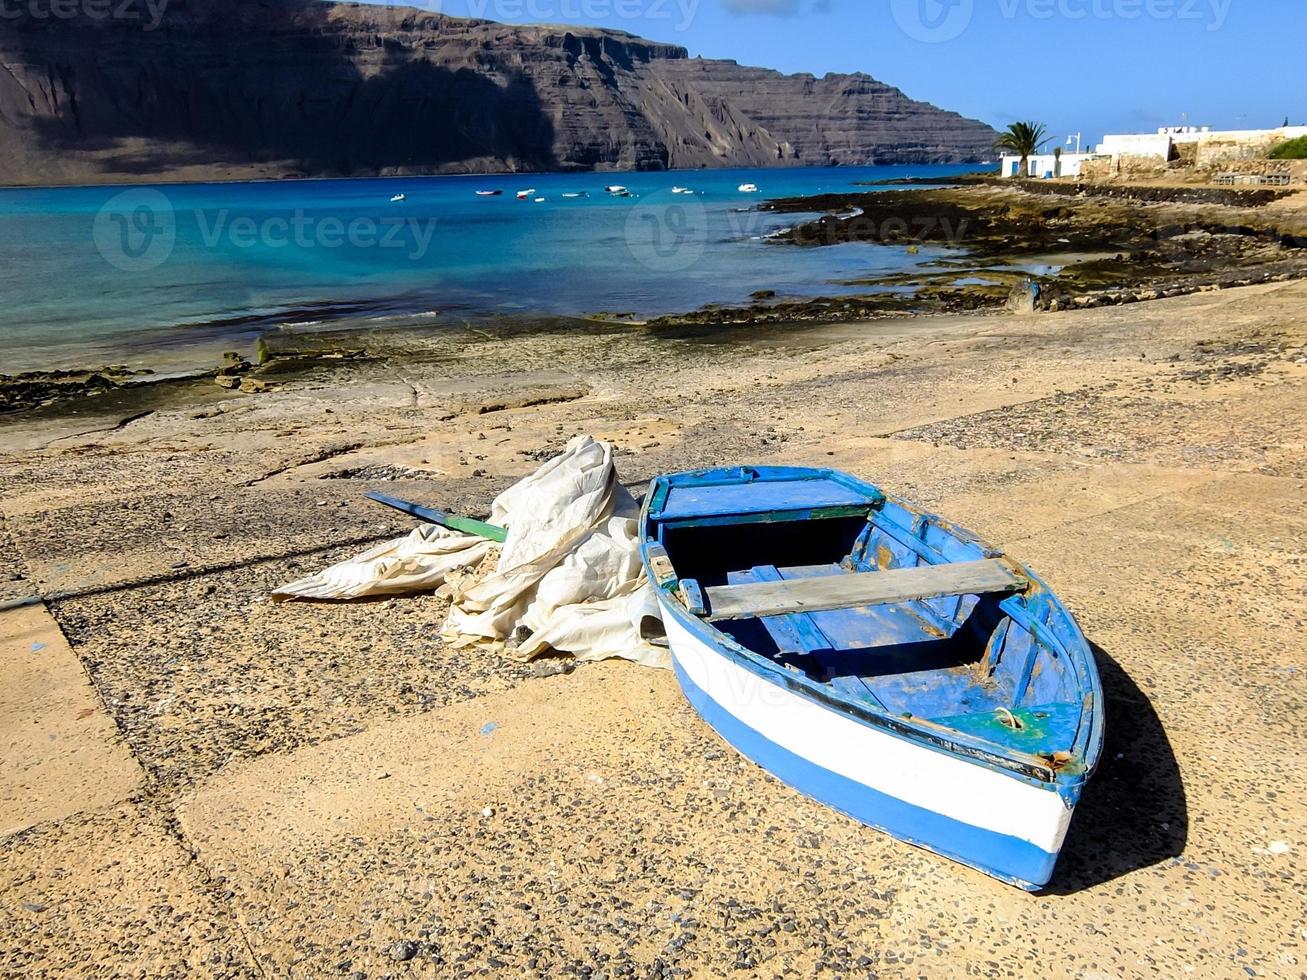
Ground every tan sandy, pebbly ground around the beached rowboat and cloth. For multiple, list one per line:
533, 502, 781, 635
0, 280, 1307, 980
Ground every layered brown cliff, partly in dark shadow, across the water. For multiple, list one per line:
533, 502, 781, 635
0, 0, 996, 184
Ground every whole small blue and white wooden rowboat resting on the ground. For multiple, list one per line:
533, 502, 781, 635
640, 466, 1103, 890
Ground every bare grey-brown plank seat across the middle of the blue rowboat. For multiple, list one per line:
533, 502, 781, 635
704, 558, 1026, 622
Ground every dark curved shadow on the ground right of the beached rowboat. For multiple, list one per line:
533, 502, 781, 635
1043, 643, 1189, 895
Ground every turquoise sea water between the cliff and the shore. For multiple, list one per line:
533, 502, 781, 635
0, 166, 974, 374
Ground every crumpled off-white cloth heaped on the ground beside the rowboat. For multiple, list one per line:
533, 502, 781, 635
272, 435, 672, 668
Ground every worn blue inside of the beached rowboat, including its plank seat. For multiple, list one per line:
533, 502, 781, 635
647, 470, 1085, 763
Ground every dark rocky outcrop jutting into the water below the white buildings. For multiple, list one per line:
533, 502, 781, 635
645, 175, 1307, 329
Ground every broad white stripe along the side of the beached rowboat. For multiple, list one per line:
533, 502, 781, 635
663, 605, 1073, 855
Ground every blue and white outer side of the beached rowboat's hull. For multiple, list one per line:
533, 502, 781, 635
660, 611, 1080, 890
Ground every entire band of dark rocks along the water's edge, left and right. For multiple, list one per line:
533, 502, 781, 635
10, 175, 1307, 417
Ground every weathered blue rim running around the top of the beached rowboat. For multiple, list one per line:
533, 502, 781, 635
640, 466, 1103, 797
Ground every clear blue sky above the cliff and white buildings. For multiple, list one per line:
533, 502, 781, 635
397, 0, 1307, 142
